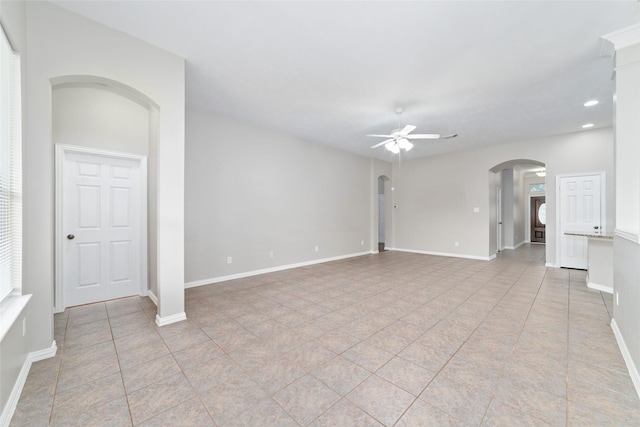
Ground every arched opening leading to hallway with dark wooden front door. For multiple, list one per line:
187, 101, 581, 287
489, 159, 546, 254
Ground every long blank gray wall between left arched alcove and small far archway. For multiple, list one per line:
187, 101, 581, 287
185, 110, 377, 286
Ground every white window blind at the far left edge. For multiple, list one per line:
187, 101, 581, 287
0, 24, 22, 301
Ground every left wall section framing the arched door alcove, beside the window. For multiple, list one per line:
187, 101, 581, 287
23, 2, 184, 351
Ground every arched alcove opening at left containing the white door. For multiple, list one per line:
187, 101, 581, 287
51, 75, 158, 312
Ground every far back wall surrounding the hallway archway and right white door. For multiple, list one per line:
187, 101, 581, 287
394, 128, 615, 265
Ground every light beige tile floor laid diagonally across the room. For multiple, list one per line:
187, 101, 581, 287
11, 245, 640, 426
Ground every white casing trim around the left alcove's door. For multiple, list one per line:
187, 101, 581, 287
53, 144, 149, 313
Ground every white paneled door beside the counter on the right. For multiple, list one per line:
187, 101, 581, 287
560, 175, 602, 270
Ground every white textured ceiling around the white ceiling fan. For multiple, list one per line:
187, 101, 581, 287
54, 0, 640, 160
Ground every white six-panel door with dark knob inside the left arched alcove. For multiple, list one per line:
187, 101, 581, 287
58, 152, 143, 307
